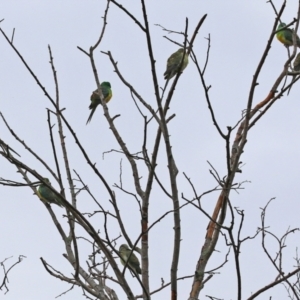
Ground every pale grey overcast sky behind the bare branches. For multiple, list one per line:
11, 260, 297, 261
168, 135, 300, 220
0, 0, 300, 300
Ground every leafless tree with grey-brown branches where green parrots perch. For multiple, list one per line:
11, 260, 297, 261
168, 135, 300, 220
0, 0, 300, 300
